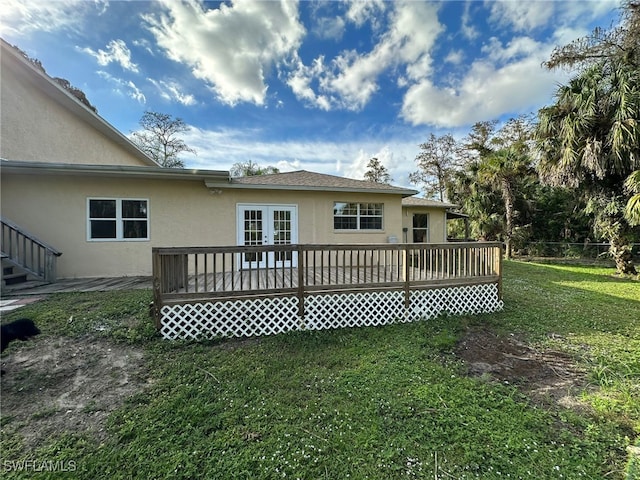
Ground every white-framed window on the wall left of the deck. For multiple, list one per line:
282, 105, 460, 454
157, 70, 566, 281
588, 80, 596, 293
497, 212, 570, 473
87, 198, 149, 241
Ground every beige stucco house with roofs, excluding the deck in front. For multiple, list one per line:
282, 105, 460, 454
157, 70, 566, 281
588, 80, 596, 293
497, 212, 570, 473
0, 41, 452, 278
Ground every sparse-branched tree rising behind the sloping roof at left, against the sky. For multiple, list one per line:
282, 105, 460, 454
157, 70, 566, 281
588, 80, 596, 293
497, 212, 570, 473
132, 111, 196, 168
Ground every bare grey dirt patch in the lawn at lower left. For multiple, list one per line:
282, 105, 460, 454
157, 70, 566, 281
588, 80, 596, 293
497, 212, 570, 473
2, 337, 147, 448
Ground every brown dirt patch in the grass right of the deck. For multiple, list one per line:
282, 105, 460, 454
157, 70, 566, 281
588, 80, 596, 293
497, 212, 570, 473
456, 327, 587, 408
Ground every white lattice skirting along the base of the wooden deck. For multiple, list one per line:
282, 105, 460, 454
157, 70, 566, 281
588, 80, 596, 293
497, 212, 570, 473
160, 283, 503, 340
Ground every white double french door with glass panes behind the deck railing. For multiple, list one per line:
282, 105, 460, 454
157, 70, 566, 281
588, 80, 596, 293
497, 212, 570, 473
238, 205, 298, 268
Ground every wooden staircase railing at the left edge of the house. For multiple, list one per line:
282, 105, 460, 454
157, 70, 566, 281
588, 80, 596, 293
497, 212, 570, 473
0, 218, 62, 282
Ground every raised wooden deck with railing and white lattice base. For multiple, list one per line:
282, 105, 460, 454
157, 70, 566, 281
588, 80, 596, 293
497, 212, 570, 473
153, 242, 502, 338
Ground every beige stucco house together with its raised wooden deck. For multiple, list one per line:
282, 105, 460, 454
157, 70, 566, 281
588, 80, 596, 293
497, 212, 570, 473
0, 41, 502, 339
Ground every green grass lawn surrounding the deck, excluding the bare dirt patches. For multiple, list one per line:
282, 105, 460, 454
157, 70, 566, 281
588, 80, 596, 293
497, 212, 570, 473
1, 262, 640, 479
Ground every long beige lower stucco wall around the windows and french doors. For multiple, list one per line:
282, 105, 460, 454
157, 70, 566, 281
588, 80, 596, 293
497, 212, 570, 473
0, 174, 403, 278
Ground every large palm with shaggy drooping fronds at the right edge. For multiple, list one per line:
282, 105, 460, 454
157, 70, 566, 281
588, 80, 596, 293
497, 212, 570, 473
536, 59, 640, 274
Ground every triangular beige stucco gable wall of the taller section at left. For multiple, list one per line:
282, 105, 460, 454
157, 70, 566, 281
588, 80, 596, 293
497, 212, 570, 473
0, 50, 147, 165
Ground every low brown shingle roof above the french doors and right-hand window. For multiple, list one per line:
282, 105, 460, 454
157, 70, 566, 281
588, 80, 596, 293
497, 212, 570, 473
231, 170, 417, 196
